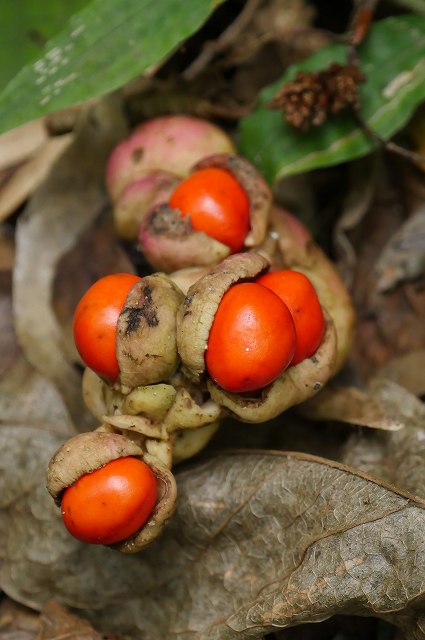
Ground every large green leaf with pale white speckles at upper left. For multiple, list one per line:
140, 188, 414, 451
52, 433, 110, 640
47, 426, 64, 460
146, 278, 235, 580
0, 0, 220, 131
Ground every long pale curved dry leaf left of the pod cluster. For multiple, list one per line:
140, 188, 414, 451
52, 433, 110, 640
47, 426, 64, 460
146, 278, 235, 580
14, 98, 125, 428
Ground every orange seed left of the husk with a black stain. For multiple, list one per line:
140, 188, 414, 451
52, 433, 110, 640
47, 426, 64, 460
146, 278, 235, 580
74, 273, 140, 381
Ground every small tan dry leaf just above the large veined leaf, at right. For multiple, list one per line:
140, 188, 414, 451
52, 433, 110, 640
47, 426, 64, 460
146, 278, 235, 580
299, 380, 404, 431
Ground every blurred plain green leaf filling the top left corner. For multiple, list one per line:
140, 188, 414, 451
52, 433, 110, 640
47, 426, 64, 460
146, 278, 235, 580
0, 0, 88, 88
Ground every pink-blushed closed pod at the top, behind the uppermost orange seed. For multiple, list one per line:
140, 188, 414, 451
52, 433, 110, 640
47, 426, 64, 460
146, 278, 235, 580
106, 115, 235, 240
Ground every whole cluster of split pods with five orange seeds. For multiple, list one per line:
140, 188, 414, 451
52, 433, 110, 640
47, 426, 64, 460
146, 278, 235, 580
48, 116, 353, 552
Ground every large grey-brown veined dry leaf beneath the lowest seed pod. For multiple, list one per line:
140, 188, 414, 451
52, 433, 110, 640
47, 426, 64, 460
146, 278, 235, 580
0, 428, 425, 640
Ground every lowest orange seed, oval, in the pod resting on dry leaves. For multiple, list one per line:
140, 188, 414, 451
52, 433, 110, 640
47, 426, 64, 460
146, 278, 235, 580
61, 457, 157, 544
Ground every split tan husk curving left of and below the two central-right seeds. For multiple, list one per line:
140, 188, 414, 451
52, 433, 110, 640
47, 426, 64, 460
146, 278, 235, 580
177, 251, 337, 423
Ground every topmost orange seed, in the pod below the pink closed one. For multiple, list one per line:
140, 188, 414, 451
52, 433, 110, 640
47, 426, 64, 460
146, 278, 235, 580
169, 167, 250, 253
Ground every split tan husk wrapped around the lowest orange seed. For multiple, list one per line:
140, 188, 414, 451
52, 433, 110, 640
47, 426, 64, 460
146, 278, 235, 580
47, 431, 177, 553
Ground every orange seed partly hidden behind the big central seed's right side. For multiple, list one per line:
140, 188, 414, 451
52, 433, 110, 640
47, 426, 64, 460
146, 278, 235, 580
256, 269, 325, 365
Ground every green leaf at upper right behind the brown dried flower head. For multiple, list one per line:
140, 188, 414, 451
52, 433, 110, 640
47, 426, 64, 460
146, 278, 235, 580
239, 15, 425, 183
